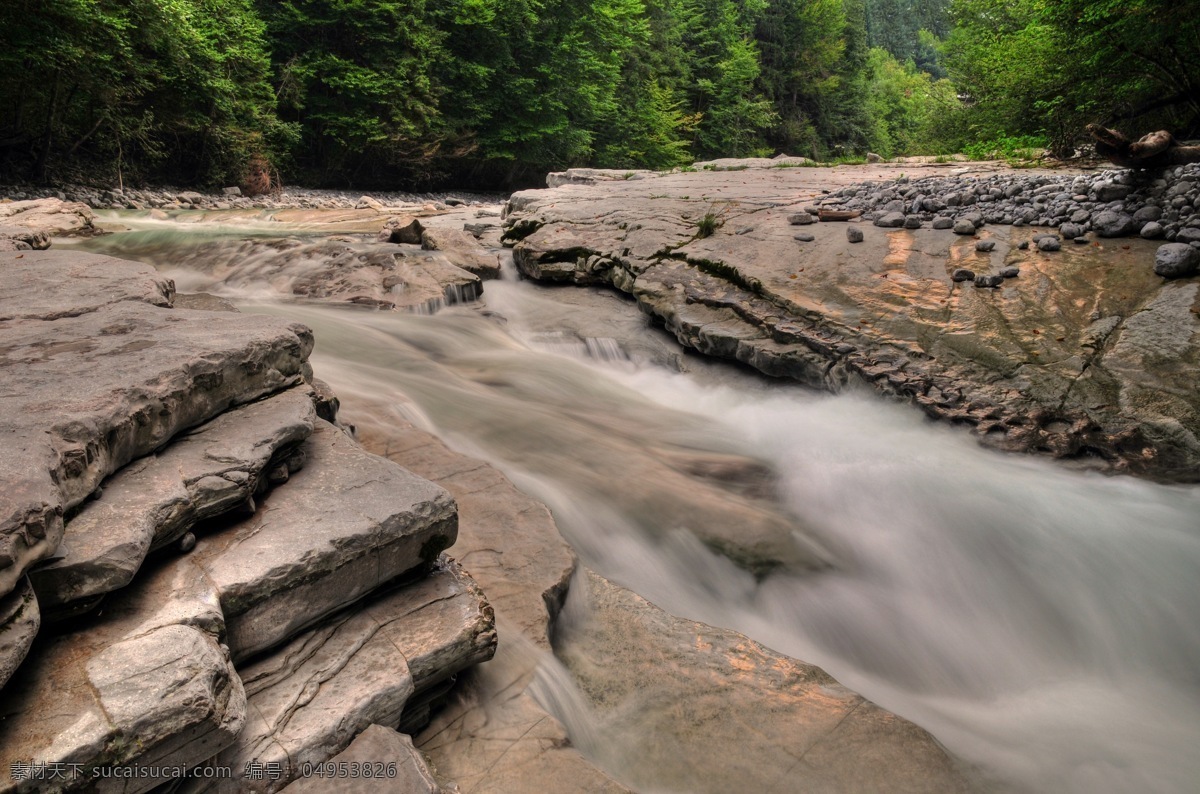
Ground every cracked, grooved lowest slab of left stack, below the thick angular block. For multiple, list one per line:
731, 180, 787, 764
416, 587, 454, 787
185, 558, 496, 792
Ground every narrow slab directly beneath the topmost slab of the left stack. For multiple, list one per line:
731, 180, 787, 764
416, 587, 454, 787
30, 389, 316, 609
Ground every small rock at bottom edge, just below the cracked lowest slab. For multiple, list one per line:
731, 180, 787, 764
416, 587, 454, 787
281, 724, 443, 794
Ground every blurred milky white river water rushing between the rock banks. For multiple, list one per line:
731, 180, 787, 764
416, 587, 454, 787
72, 213, 1200, 792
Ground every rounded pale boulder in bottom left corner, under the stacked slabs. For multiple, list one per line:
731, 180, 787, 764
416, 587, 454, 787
0, 561, 246, 793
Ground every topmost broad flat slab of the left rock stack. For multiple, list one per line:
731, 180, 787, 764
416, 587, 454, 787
0, 252, 312, 593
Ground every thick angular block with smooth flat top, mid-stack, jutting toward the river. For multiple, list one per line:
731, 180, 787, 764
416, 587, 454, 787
191, 420, 457, 662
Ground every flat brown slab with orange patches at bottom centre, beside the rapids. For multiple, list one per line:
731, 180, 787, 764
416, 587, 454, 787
558, 572, 976, 793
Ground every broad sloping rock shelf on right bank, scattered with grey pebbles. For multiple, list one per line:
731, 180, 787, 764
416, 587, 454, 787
505, 166, 1200, 481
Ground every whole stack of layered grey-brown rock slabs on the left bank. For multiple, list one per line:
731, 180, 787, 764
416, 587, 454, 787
0, 249, 497, 792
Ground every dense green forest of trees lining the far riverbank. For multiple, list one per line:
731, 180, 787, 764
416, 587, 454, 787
0, 0, 1200, 187
